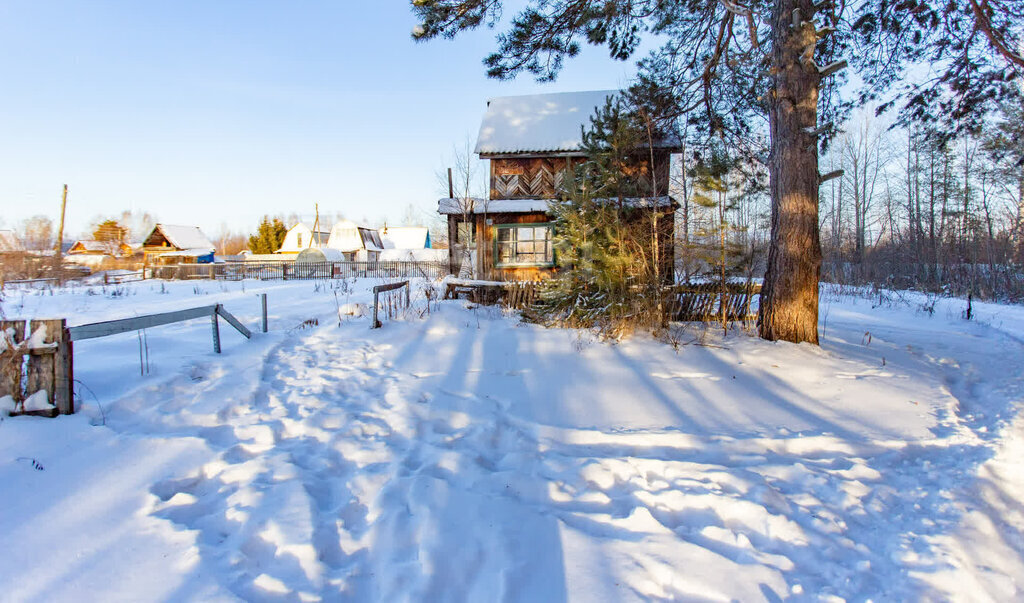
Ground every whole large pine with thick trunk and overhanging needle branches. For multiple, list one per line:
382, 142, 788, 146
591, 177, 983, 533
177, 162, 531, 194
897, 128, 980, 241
412, 0, 1024, 342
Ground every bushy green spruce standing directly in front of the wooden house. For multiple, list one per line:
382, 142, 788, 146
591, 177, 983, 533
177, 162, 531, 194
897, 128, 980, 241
531, 98, 665, 338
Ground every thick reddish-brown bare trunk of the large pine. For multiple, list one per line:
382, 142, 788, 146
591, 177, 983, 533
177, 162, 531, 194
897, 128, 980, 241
758, 0, 821, 344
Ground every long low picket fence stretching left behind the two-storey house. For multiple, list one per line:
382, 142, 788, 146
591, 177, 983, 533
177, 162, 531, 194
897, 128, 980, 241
148, 261, 449, 281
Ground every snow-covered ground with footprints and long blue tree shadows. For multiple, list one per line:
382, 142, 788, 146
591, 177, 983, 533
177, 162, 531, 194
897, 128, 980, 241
0, 281, 1024, 601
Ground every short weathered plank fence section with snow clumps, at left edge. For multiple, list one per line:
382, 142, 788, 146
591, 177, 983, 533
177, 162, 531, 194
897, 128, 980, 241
0, 318, 75, 417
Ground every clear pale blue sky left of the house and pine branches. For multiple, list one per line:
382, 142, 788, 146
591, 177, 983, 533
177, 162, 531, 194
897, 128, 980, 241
0, 0, 633, 236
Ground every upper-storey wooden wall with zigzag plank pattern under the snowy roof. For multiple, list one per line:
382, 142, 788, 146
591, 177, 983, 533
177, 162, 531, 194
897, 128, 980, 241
481, 149, 670, 199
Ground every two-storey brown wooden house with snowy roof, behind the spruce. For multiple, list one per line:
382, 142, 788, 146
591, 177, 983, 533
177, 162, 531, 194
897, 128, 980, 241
438, 90, 677, 281
